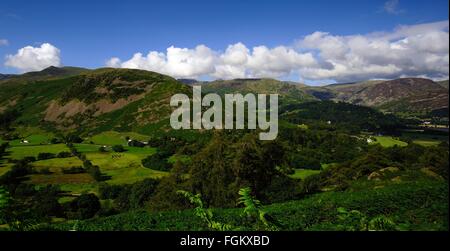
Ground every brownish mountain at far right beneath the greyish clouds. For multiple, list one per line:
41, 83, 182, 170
306, 78, 448, 114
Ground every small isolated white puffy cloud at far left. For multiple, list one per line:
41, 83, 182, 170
5, 43, 61, 72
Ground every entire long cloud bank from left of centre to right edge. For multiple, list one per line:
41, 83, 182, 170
106, 20, 449, 82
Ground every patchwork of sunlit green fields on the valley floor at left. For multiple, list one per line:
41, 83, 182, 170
0, 131, 165, 195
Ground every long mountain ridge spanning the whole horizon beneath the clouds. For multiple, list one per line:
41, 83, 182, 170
0, 67, 448, 130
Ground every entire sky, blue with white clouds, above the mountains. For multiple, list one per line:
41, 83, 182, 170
0, 0, 449, 84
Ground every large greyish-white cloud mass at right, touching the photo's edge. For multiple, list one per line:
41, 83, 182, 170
298, 21, 449, 81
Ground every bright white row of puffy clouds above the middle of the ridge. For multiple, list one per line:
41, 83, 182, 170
107, 43, 316, 79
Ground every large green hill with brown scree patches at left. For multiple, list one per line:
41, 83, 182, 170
0, 68, 192, 133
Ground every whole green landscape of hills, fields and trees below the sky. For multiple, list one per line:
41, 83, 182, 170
0, 68, 448, 233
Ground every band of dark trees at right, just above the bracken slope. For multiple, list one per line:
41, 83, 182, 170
302, 142, 449, 193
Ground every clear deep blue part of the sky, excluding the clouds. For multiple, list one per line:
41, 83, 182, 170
0, 0, 448, 81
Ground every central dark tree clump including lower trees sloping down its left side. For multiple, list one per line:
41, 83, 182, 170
144, 131, 296, 210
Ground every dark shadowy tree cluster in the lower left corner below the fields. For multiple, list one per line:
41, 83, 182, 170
0, 160, 100, 226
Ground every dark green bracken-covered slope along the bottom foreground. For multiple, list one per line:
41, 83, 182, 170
48, 178, 448, 231
